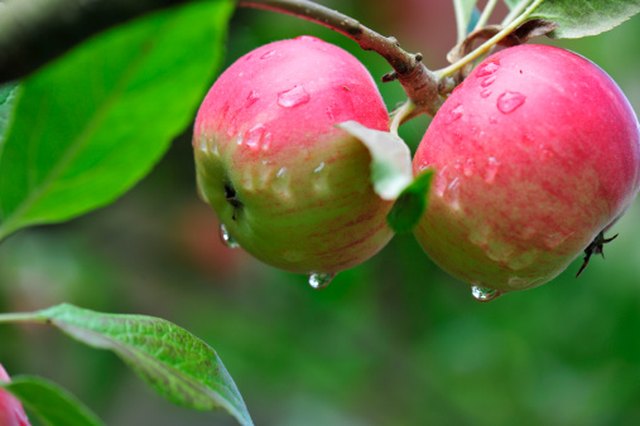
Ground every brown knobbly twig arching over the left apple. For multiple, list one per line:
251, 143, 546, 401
238, 0, 444, 117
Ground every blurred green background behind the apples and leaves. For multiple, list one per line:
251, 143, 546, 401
0, 0, 640, 426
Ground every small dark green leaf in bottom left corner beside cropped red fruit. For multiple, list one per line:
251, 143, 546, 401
0, 376, 103, 426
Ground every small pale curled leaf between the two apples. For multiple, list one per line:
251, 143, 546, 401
338, 121, 413, 200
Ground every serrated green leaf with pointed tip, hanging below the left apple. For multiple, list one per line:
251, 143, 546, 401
37, 304, 253, 425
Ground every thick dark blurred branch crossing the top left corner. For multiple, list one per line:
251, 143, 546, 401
0, 0, 187, 84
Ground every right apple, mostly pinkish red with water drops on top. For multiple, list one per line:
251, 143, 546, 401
413, 45, 640, 292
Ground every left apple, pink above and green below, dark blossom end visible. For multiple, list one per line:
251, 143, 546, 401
193, 36, 392, 274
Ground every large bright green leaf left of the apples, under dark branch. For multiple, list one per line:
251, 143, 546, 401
0, 0, 233, 238
